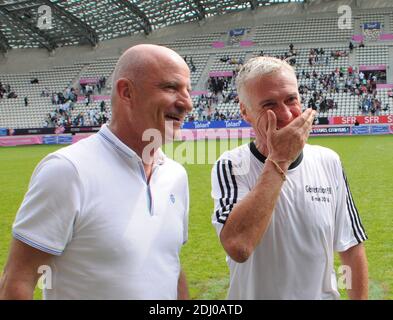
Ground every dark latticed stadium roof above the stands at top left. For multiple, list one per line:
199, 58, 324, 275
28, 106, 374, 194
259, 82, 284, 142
0, 0, 306, 52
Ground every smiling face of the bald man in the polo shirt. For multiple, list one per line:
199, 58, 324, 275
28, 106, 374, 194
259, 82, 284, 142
134, 57, 192, 143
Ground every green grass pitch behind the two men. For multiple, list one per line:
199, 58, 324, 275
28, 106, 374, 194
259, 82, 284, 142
0, 136, 393, 299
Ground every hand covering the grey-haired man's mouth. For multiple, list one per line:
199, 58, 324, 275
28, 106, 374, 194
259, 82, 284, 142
266, 108, 316, 169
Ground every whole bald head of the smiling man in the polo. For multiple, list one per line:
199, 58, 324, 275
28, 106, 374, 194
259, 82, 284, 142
110, 44, 192, 155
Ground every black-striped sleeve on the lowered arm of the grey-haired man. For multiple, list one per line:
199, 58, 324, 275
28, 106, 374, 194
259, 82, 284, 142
334, 165, 367, 252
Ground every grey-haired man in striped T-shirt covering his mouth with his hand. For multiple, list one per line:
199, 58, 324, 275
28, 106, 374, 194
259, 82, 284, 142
212, 57, 368, 299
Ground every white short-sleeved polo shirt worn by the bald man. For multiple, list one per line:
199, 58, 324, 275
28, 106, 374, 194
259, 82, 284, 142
13, 125, 189, 299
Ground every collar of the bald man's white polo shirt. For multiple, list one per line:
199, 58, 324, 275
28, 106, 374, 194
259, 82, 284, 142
98, 124, 166, 165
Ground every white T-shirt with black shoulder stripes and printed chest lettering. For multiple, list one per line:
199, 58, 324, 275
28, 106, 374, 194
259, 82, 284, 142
212, 143, 367, 299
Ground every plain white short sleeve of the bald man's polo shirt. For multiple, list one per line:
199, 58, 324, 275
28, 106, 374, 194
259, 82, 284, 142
13, 154, 81, 255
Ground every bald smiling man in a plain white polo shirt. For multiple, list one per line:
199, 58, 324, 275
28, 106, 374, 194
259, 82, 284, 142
0, 45, 192, 299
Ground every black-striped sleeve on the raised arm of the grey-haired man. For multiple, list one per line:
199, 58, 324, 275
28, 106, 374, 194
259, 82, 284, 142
211, 159, 250, 235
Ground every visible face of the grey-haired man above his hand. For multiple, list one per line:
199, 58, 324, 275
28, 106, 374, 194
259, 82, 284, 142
241, 69, 302, 141
